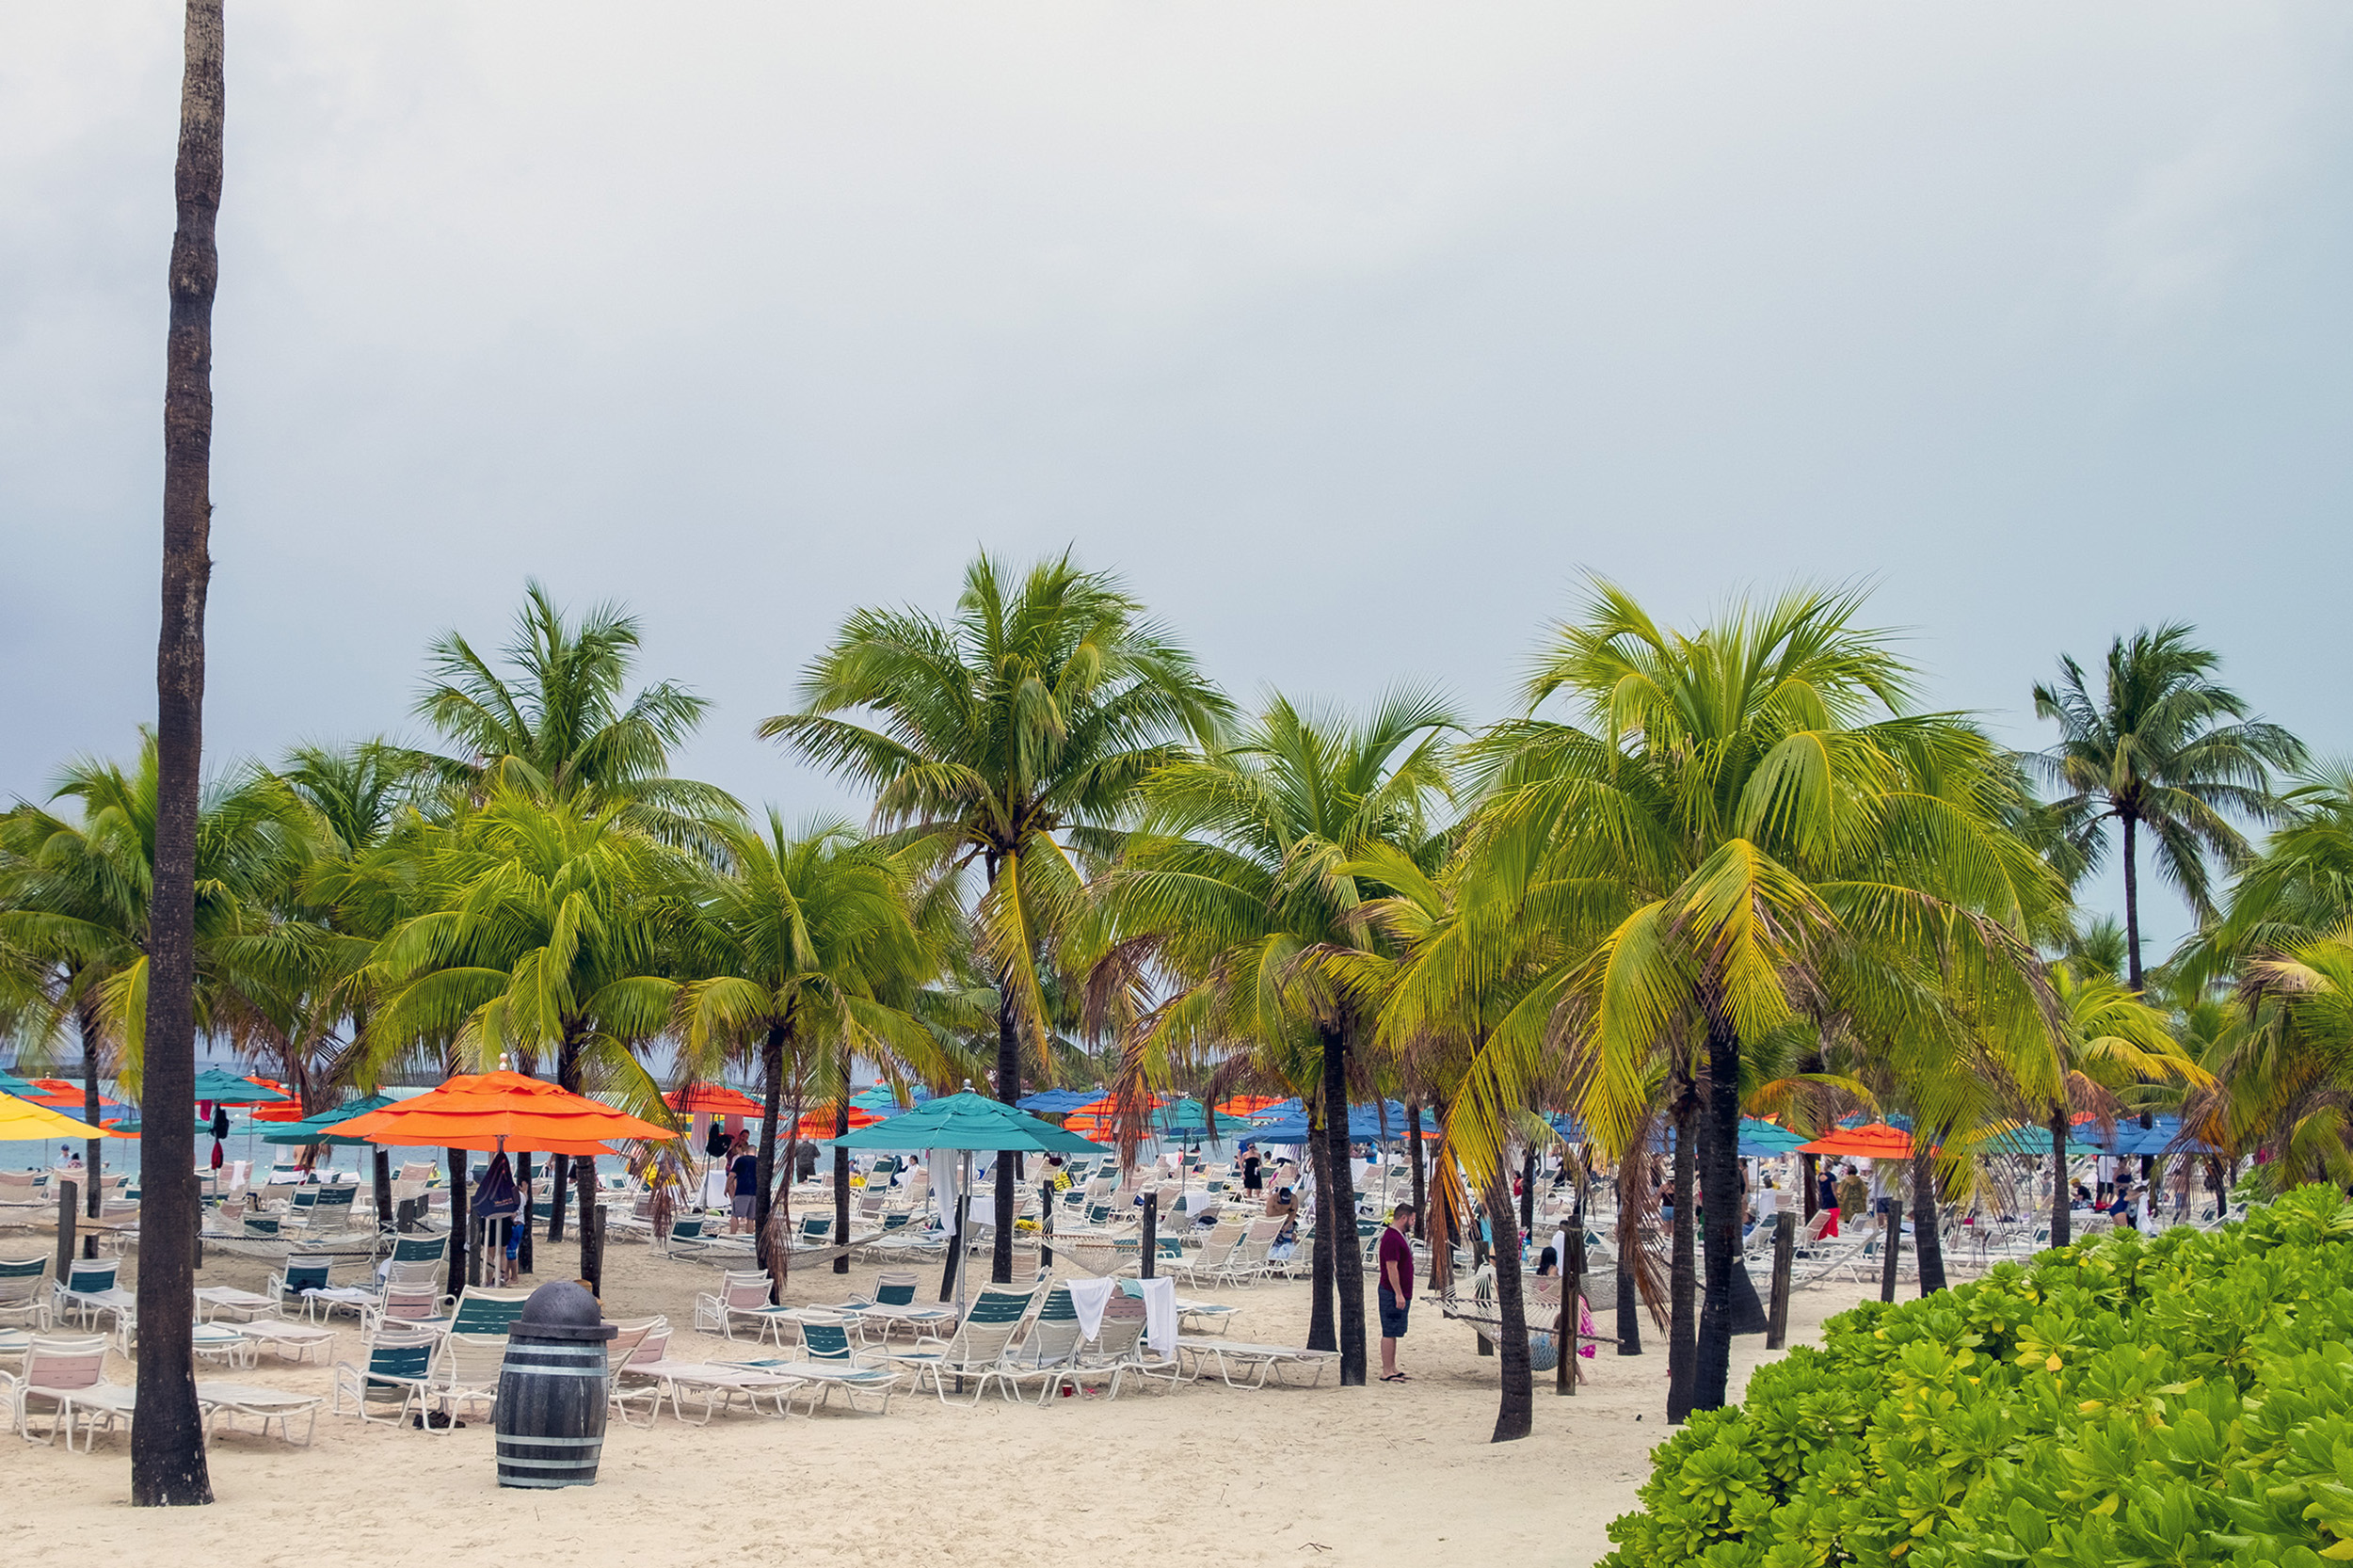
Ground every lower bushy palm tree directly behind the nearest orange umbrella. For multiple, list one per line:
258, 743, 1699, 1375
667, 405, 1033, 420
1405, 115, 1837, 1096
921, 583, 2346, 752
353, 792, 701, 1278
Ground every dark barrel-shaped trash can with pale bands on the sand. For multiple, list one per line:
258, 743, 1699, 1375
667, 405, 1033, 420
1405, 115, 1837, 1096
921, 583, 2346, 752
499, 1278, 619, 1488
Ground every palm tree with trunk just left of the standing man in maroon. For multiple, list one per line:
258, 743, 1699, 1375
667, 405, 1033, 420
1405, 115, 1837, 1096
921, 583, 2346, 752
1104, 692, 1457, 1384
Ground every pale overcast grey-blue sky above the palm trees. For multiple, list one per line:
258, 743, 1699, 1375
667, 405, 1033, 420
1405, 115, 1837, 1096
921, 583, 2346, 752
0, 0, 2353, 952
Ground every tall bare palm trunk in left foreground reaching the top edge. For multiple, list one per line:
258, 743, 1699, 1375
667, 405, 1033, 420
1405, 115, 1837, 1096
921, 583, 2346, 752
132, 0, 226, 1507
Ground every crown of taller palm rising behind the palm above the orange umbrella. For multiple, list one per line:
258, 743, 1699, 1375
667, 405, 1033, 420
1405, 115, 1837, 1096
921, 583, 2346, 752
417, 582, 742, 840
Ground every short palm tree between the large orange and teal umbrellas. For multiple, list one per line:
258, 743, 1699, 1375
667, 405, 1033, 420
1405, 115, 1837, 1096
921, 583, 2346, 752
678, 812, 963, 1272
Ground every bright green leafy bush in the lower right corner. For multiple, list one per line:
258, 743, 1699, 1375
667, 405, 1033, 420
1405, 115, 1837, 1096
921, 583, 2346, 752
1605, 1187, 2353, 1568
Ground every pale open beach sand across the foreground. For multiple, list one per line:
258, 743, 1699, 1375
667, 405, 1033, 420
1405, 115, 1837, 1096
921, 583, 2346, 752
0, 1239, 1857, 1568
